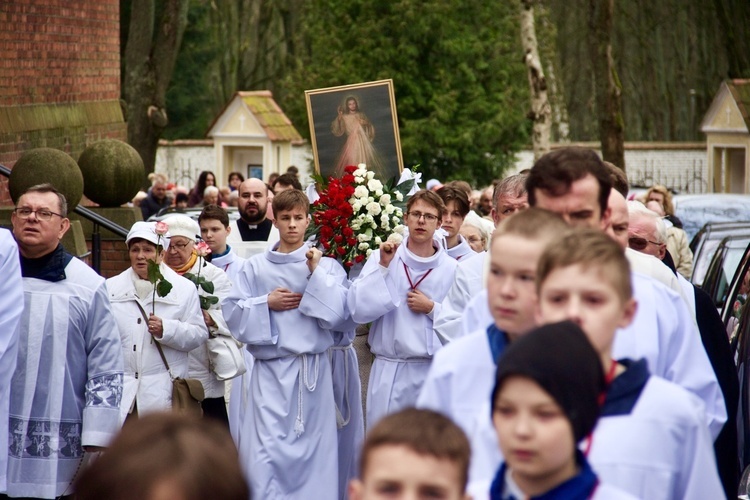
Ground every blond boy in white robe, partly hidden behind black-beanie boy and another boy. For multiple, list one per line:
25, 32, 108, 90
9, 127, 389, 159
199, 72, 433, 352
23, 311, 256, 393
417, 208, 568, 482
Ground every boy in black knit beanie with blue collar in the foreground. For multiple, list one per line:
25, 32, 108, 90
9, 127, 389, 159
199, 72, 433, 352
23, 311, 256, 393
490, 322, 635, 500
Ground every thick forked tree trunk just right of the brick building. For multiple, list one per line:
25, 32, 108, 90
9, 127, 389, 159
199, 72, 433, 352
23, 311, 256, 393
122, 0, 189, 178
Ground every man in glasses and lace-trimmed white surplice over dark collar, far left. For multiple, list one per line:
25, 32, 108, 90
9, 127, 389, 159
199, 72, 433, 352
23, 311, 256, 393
5, 184, 123, 498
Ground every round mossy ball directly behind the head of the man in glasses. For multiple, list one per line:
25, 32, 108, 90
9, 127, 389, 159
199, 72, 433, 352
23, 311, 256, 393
8, 148, 83, 212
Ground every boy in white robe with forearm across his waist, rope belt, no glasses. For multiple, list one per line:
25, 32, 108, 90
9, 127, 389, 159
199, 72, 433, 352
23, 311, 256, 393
223, 189, 348, 500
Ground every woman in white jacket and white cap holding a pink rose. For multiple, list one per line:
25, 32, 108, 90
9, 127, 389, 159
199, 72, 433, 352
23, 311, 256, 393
107, 222, 208, 420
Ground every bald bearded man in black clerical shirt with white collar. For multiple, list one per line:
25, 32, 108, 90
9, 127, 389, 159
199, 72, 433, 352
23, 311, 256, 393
227, 179, 279, 259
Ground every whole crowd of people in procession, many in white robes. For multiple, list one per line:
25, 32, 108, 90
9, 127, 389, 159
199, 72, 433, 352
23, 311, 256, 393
0, 147, 740, 500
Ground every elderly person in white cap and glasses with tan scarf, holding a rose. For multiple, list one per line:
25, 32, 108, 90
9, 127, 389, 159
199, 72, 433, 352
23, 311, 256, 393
164, 214, 232, 426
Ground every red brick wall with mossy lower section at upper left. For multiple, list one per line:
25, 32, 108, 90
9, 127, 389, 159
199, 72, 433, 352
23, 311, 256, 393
0, 0, 127, 204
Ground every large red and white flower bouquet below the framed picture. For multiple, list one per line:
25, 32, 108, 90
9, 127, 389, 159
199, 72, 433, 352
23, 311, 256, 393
306, 163, 415, 273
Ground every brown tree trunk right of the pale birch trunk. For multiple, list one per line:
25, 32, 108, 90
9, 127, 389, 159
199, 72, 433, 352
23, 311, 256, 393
589, 0, 625, 170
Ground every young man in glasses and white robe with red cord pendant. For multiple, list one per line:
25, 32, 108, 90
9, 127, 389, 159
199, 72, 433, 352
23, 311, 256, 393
347, 189, 456, 426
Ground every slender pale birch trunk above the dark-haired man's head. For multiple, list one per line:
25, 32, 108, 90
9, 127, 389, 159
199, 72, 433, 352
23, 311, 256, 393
521, 0, 552, 160
